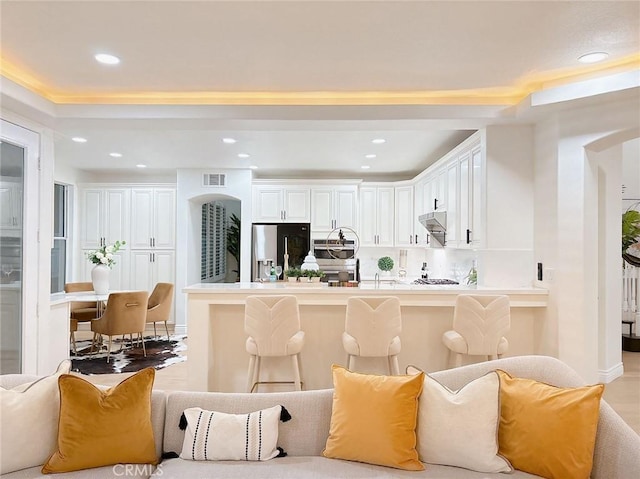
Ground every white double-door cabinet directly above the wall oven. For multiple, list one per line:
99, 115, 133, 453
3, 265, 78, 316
311, 185, 358, 233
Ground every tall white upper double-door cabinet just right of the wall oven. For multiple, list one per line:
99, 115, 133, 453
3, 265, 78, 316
358, 186, 394, 246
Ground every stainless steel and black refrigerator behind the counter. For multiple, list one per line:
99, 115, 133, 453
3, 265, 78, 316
251, 223, 310, 281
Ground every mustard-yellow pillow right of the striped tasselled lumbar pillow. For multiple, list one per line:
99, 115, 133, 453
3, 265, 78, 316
322, 365, 424, 471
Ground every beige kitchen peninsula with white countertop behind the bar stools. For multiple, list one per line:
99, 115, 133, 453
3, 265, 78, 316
183, 282, 548, 392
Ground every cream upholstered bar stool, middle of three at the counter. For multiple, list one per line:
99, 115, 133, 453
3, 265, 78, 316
342, 296, 402, 374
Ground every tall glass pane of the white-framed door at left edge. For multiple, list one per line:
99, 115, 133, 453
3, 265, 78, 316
0, 140, 25, 374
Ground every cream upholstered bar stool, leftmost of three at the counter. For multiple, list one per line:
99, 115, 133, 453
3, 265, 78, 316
244, 295, 304, 392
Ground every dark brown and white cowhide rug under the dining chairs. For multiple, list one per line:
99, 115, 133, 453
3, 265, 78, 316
71, 336, 187, 374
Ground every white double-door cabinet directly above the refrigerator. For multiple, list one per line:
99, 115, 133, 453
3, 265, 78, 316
252, 185, 311, 223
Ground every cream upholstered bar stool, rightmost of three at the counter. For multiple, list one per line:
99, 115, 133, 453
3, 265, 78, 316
442, 294, 511, 367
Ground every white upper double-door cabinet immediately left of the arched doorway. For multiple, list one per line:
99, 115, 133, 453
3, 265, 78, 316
130, 187, 176, 249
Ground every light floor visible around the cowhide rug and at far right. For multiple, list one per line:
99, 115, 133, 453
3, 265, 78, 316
76, 336, 640, 434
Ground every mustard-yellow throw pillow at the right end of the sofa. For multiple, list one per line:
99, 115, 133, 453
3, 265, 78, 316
498, 370, 604, 479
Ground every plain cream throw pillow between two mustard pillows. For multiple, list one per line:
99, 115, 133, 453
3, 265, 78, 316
407, 366, 513, 472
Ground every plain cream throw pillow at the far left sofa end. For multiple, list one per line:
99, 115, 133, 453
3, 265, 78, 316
0, 359, 71, 475
